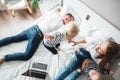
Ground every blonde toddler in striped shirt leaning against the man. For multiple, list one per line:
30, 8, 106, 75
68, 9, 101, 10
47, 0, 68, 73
43, 21, 79, 54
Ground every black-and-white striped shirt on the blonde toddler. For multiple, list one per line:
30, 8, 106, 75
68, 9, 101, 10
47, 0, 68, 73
43, 29, 66, 47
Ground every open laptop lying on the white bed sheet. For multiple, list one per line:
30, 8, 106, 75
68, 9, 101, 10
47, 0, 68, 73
22, 57, 48, 79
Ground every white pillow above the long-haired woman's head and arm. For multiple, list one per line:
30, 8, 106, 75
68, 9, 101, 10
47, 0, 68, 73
75, 20, 112, 41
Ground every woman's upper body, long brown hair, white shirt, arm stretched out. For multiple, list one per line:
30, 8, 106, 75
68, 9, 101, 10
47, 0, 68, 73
72, 38, 119, 70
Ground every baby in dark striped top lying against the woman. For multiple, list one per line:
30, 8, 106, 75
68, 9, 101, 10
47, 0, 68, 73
76, 59, 103, 80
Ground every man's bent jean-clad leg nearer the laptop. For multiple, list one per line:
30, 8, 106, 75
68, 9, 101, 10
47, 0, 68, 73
5, 35, 42, 61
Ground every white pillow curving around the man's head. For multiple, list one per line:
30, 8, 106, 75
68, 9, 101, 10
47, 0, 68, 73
60, 6, 82, 26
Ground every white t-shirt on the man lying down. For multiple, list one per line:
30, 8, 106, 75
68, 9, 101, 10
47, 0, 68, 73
37, 13, 63, 34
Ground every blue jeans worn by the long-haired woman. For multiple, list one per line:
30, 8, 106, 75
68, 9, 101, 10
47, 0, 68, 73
55, 48, 91, 80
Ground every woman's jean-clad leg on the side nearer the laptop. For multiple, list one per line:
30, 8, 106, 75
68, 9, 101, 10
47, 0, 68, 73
55, 57, 80, 80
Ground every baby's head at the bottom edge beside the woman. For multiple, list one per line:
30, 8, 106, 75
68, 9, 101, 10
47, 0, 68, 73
89, 70, 101, 80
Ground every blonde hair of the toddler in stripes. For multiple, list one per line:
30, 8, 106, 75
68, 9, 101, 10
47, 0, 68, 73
62, 21, 80, 38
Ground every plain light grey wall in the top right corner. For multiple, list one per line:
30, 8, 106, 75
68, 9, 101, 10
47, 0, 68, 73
80, 0, 120, 30
